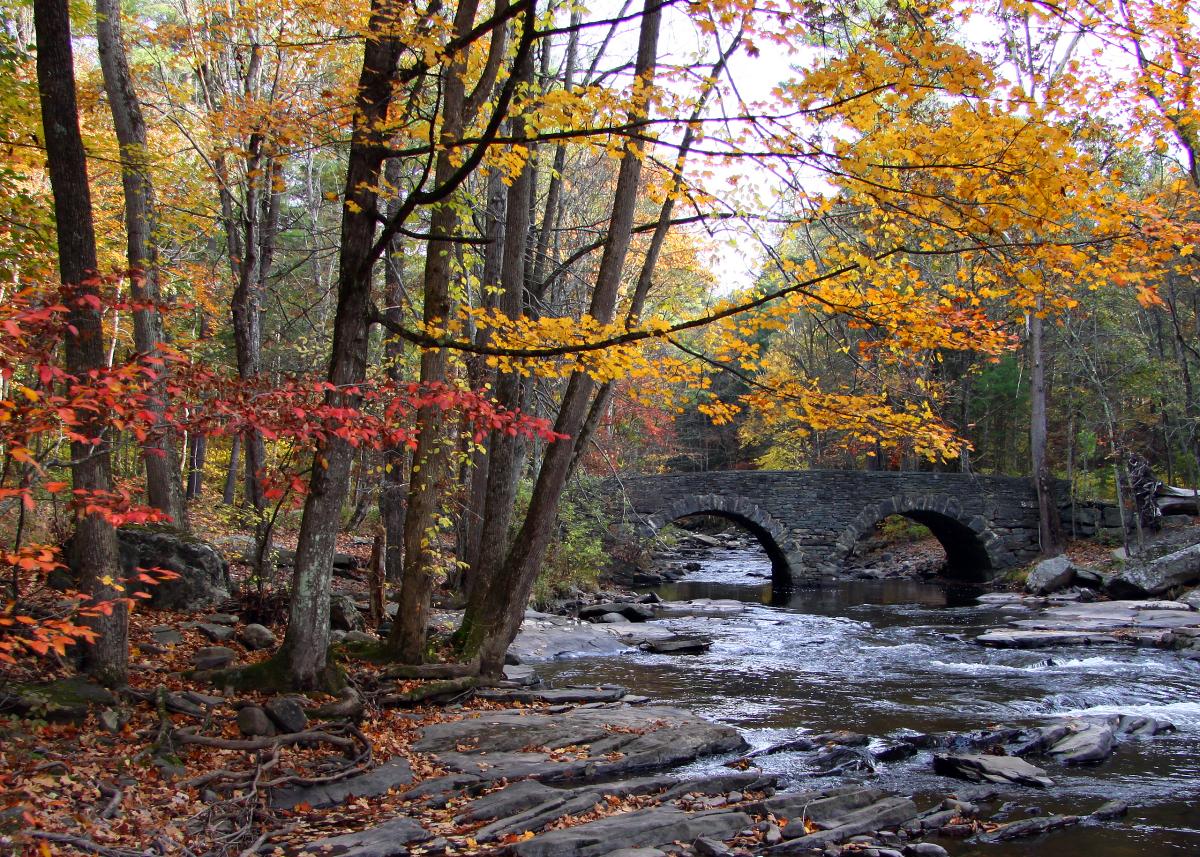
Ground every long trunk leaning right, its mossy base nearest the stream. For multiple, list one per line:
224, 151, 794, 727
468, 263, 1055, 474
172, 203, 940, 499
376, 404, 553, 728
462, 0, 661, 676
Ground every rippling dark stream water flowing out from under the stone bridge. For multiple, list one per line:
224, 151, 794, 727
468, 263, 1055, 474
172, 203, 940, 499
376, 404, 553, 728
539, 550, 1200, 857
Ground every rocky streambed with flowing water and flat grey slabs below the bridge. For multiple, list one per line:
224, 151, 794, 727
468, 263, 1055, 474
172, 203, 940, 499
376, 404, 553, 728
278, 532, 1200, 857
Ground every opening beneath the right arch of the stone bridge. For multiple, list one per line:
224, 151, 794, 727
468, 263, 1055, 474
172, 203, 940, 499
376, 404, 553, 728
851, 510, 995, 583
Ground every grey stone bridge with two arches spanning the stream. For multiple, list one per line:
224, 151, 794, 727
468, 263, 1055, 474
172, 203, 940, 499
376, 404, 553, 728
620, 471, 1066, 582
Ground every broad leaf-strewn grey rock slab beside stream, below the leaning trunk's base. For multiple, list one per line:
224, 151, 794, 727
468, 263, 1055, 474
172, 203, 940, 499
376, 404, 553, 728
414, 706, 746, 781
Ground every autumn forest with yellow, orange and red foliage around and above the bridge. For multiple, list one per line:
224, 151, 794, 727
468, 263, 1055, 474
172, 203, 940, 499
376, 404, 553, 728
0, 0, 1200, 853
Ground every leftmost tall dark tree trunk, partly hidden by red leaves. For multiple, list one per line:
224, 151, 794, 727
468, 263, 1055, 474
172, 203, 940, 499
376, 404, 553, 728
34, 0, 128, 685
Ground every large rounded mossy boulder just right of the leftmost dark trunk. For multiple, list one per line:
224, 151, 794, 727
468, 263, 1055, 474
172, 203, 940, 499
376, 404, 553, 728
115, 526, 233, 610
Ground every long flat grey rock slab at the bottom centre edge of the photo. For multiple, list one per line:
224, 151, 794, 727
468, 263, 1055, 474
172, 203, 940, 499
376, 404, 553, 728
512, 807, 754, 857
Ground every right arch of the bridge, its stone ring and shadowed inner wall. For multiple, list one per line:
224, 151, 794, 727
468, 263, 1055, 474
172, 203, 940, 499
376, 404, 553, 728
838, 493, 1015, 581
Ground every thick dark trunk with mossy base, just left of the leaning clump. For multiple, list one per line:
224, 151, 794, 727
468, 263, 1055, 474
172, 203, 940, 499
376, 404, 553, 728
282, 0, 402, 688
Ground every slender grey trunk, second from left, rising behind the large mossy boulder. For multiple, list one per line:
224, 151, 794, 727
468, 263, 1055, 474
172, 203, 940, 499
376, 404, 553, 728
96, 0, 187, 529
